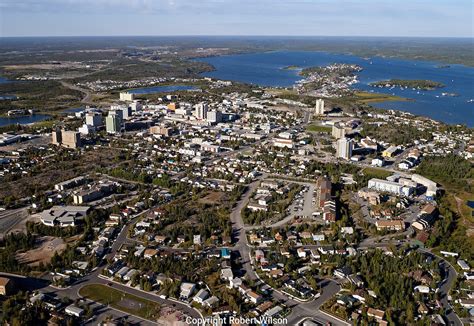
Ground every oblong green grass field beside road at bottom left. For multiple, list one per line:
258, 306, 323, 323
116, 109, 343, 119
79, 284, 160, 320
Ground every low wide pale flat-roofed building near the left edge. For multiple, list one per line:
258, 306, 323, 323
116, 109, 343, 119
40, 206, 90, 227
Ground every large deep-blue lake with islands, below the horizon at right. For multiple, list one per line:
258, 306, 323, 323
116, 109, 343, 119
197, 51, 474, 127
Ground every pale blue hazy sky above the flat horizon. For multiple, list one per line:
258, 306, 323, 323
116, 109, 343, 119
0, 0, 474, 37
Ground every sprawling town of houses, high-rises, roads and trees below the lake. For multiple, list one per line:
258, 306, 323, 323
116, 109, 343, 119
0, 66, 474, 326
